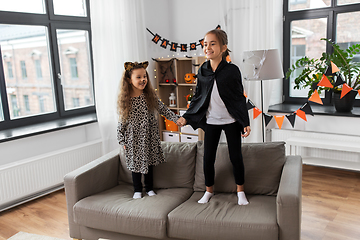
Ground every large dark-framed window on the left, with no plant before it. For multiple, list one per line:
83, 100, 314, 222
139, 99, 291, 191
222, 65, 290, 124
0, 0, 95, 133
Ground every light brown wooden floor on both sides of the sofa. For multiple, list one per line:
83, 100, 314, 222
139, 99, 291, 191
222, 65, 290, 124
0, 166, 360, 240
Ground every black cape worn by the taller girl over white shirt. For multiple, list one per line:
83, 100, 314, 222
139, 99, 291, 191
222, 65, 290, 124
183, 59, 250, 131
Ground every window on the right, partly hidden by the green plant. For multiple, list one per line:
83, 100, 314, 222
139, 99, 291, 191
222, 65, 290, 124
284, 0, 360, 106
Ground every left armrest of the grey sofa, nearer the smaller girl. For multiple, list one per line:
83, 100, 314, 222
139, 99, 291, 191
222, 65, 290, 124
64, 149, 120, 238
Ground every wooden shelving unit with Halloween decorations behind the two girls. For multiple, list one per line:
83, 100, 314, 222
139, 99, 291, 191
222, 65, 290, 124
155, 57, 205, 142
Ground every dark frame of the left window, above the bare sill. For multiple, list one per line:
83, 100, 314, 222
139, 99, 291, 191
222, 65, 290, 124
0, 0, 96, 130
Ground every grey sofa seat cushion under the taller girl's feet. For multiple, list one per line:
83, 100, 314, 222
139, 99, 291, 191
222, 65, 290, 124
168, 192, 278, 240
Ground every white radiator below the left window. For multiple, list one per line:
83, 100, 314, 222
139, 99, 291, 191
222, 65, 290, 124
0, 140, 102, 212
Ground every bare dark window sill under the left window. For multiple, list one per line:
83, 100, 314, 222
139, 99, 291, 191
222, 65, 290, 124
0, 113, 97, 143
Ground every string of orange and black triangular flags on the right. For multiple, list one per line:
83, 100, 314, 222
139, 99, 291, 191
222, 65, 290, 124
244, 62, 360, 129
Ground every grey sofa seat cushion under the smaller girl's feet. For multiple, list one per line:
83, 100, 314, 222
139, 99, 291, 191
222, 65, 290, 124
74, 184, 193, 239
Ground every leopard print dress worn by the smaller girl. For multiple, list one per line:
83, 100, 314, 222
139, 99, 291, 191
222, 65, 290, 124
117, 94, 180, 174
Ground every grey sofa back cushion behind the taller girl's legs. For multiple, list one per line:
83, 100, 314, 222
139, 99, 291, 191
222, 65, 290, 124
194, 142, 285, 195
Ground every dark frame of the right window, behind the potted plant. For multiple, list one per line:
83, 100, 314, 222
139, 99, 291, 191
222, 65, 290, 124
283, 0, 360, 107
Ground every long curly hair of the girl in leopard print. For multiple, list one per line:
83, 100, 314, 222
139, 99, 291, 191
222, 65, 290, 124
117, 62, 158, 122
